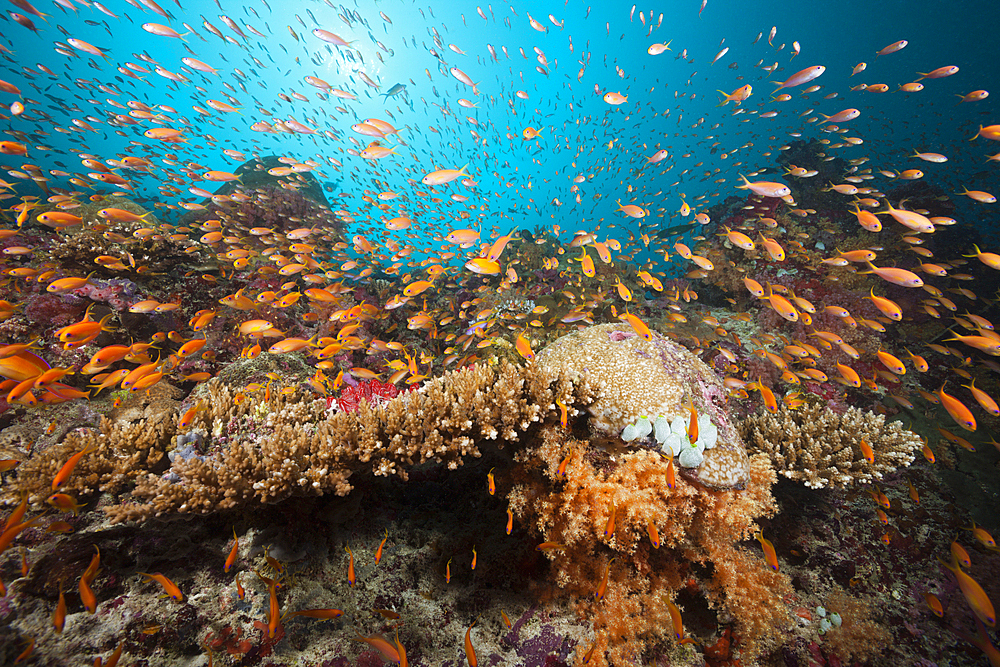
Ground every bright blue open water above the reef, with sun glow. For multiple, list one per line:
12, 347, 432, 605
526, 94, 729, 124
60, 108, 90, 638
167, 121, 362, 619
0, 0, 1000, 256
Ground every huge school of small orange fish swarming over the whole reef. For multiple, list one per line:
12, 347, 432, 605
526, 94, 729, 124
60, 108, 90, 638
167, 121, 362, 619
0, 0, 1000, 667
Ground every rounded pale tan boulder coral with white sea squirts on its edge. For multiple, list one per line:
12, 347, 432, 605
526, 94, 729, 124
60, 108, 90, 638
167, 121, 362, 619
538, 324, 749, 489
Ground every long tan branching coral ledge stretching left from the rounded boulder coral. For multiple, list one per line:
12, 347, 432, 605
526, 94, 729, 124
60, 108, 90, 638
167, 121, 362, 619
8, 364, 576, 521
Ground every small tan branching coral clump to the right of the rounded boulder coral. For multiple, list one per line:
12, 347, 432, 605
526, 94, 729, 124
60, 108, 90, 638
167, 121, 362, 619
740, 402, 922, 489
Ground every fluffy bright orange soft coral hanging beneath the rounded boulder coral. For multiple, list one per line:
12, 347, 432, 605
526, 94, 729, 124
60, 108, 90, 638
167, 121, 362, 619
508, 426, 791, 665
